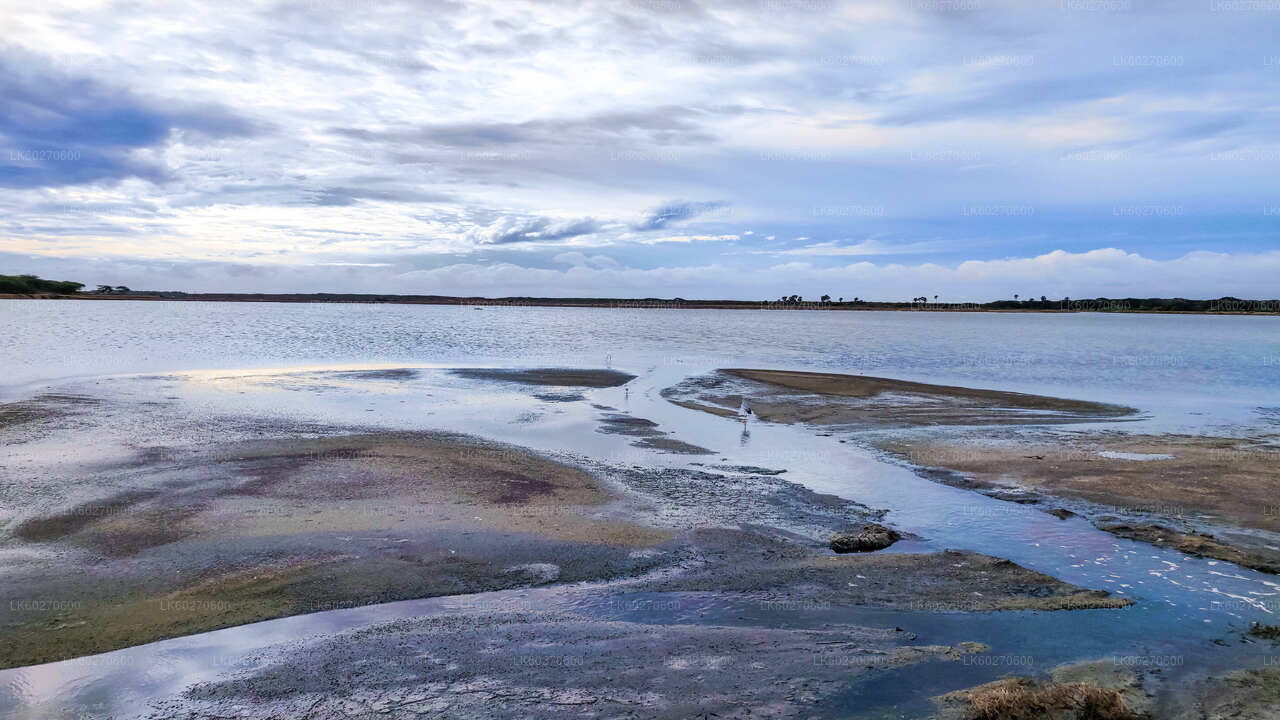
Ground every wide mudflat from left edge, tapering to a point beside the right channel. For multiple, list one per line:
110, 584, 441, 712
0, 381, 1126, 667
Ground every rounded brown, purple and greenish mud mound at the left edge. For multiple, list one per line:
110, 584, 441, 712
0, 433, 672, 666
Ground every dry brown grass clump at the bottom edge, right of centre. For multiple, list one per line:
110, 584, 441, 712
968, 682, 1144, 720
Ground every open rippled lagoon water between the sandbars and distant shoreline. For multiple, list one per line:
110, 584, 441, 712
0, 300, 1280, 427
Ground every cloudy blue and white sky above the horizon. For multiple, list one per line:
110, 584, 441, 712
0, 0, 1280, 301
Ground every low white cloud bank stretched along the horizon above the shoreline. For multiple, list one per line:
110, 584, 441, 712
12, 247, 1280, 302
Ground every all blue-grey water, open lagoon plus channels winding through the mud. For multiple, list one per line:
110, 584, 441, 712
0, 301, 1280, 717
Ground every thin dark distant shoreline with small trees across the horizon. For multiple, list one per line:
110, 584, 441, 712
0, 292, 1280, 315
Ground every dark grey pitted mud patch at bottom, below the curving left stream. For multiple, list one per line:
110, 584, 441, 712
160, 610, 983, 720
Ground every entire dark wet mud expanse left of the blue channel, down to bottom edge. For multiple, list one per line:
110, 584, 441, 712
0, 370, 1269, 717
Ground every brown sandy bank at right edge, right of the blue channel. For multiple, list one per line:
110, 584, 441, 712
877, 432, 1280, 573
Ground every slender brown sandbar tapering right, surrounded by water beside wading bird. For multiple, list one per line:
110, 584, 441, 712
663, 369, 1137, 427
